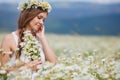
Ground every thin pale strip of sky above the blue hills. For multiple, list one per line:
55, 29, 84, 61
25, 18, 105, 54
0, 0, 120, 4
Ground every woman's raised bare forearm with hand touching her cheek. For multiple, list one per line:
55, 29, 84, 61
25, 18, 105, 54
36, 25, 57, 64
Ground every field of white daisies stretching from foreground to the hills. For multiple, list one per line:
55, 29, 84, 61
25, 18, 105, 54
0, 34, 120, 80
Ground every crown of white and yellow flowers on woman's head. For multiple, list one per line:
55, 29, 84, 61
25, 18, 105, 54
18, 0, 52, 12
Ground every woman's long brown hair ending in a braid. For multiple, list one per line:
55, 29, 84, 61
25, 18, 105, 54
18, 7, 47, 56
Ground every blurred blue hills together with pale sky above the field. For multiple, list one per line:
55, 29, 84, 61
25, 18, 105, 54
0, 0, 120, 36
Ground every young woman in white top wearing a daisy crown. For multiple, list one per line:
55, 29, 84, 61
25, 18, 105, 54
1, 2, 57, 71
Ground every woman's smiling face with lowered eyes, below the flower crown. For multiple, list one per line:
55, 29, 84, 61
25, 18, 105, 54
27, 12, 47, 31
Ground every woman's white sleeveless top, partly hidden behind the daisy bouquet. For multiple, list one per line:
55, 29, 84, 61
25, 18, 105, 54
11, 32, 45, 64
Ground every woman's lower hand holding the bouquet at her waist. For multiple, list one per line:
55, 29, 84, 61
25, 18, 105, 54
25, 59, 42, 70
